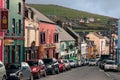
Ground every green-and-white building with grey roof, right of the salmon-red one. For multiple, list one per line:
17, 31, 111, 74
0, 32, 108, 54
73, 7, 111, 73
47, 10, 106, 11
56, 26, 76, 58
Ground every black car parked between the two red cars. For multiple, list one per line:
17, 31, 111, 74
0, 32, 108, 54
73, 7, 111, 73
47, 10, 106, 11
42, 58, 59, 74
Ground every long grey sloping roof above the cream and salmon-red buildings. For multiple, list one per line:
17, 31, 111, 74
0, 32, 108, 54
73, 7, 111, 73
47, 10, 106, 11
26, 6, 55, 24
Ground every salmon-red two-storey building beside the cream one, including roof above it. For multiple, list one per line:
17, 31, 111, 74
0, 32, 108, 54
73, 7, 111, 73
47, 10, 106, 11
38, 13, 56, 58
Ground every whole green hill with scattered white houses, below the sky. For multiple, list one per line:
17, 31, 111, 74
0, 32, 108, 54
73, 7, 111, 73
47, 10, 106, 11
27, 4, 117, 32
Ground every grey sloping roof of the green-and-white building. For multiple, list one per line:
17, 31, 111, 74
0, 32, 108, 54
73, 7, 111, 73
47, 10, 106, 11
56, 26, 75, 41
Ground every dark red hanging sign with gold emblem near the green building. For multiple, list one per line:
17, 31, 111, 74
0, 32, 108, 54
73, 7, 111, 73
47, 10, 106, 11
0, 10, 8, 30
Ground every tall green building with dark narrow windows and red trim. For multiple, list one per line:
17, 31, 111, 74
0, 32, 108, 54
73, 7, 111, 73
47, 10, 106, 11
4, 0, 25, 63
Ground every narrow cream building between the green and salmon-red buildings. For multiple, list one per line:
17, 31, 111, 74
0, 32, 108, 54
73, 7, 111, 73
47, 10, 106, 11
24, 6, 39, 60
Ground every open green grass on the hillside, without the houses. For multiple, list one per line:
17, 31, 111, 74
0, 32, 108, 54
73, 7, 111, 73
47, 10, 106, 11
27, 4, 117, 31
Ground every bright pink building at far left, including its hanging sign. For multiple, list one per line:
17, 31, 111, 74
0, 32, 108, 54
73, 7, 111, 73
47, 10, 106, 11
0, 0, 8, 61
